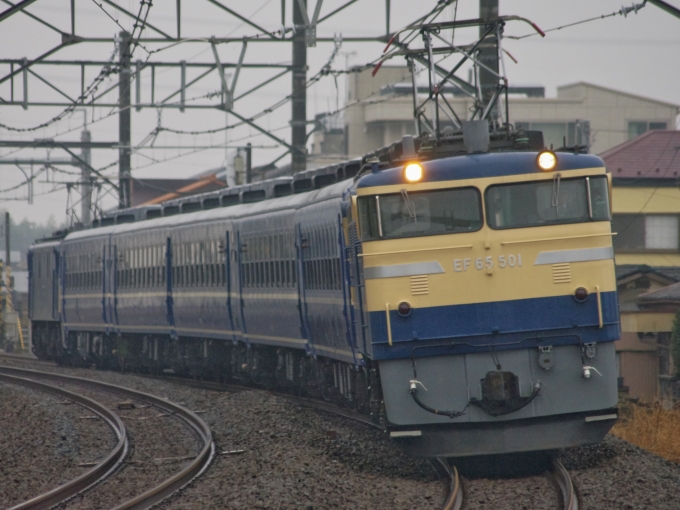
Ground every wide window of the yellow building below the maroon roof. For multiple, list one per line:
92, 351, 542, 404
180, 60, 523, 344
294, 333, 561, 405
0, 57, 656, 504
612, 214, 680, 251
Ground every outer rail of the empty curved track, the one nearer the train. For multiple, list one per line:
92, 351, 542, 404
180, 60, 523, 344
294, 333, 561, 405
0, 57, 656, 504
0, 367, 215, 510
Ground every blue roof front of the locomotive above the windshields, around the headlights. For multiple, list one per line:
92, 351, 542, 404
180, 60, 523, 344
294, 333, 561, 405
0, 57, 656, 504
357, 152, 604, 188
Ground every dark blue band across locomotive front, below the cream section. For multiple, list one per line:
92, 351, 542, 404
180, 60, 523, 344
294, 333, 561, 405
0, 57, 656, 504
370, 292, 619, 360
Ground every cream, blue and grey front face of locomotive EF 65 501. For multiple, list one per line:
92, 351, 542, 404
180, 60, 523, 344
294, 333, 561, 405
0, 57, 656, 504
357, 153, 619, 455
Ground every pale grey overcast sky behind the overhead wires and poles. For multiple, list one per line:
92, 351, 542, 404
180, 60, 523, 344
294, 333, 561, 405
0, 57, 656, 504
0, 0, 680, 222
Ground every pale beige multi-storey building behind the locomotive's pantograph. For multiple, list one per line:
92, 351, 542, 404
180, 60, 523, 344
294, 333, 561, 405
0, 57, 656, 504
313, 66, 680, 157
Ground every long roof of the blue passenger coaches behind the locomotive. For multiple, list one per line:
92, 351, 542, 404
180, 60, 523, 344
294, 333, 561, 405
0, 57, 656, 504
64, 179, 353, 243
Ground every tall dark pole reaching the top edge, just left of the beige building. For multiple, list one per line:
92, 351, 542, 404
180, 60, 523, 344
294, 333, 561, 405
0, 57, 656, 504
290, 0, 307, 173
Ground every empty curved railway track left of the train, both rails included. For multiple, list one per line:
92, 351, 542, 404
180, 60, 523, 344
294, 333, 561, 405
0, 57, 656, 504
0, 367, 215, 510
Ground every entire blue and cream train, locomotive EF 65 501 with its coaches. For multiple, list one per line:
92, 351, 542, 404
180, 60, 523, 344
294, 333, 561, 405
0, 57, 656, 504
31, 131, 619, 457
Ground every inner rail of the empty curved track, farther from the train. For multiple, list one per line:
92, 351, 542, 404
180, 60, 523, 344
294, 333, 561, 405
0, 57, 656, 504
0, 373, 128, 510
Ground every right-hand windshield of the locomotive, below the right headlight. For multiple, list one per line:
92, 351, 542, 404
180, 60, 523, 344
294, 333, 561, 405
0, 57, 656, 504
485, 174, 609, 229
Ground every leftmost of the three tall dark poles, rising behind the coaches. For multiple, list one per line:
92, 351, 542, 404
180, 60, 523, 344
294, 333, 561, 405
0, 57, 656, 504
118, 31, 131, 209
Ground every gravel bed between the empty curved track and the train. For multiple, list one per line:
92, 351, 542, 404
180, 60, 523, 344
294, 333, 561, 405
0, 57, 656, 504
1, 363, 445, 509
